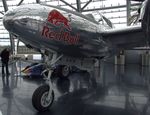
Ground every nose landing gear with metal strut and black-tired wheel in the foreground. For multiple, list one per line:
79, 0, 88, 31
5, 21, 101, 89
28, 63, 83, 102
32, 54, 62, 111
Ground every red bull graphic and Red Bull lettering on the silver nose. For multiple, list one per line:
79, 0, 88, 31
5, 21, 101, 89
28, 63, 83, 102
41, 10, 80, 45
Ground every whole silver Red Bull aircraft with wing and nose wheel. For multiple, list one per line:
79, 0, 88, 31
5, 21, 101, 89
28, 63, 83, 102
3, 0, 150, 111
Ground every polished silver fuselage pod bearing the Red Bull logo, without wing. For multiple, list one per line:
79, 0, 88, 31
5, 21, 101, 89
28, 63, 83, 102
3, 4, 111, 57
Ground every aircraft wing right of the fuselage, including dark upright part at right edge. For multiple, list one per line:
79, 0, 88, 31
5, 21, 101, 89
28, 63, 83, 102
102, 0, 150, 49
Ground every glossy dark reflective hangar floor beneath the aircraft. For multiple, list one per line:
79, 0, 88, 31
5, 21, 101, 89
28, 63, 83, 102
0, 62, 150, 115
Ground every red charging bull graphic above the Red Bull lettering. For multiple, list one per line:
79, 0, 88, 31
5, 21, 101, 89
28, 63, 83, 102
47, 10, 71, 31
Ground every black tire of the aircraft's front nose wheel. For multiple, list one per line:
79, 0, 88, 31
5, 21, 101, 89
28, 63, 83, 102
32, 85, 54, 111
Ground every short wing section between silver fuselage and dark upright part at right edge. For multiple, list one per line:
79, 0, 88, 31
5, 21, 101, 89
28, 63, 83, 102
102, 25, 146, 49
